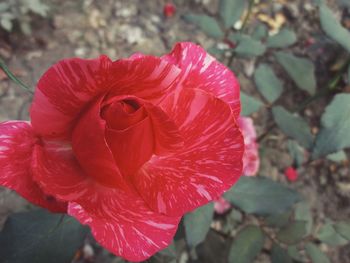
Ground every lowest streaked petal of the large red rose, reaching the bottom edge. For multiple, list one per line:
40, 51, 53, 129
68, 191, 180, 262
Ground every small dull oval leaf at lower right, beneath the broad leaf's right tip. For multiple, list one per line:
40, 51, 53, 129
277, 221, 306, 245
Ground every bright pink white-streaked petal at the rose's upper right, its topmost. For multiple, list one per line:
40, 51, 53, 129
162, 42, 240, 118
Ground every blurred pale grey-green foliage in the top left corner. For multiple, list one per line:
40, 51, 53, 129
0, 0, 49, 35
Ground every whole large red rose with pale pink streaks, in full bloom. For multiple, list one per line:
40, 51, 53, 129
0, 43, 244, 261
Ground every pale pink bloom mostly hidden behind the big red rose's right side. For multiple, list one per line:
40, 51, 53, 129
214, 117, 260, 214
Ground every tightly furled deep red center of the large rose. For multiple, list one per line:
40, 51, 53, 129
101, 98, 154, 175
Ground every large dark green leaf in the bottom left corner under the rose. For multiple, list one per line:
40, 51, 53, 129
0, 210, 87, 263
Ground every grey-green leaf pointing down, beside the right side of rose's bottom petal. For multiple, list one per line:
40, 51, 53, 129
184, 203, 214, 248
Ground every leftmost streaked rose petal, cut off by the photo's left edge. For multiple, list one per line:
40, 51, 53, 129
0, 121, 67, 212
